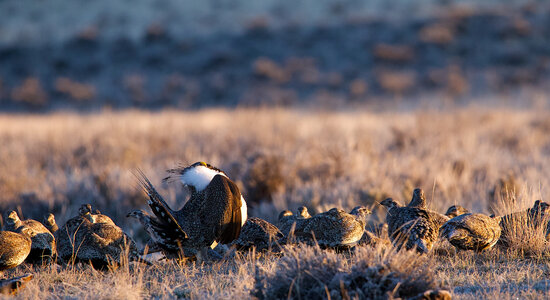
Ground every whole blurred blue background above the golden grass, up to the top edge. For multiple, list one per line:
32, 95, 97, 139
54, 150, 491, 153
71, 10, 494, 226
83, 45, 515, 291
0, 0, 550, 112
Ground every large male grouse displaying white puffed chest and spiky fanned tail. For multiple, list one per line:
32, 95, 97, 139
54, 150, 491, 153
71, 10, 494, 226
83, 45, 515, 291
129, 162, 247, 258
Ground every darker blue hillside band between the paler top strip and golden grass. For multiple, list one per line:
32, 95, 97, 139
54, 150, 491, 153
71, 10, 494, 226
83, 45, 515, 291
0, 4, 550, 111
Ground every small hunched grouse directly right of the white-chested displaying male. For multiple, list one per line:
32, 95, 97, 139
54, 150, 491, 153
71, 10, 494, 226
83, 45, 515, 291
232, 218, 283, 251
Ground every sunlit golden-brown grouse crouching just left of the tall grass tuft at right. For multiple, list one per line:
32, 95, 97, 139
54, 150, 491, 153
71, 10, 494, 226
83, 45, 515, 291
440, 213, 500, 251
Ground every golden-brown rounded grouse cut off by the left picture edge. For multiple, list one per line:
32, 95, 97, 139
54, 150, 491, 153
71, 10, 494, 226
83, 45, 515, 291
0, 232, 32, 275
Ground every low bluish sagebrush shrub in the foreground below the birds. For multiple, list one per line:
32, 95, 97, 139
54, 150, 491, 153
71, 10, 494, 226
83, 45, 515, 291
254, 245, 440, 299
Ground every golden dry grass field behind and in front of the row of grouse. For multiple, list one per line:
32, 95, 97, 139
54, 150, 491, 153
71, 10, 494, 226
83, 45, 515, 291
0, 107, 550, 299
